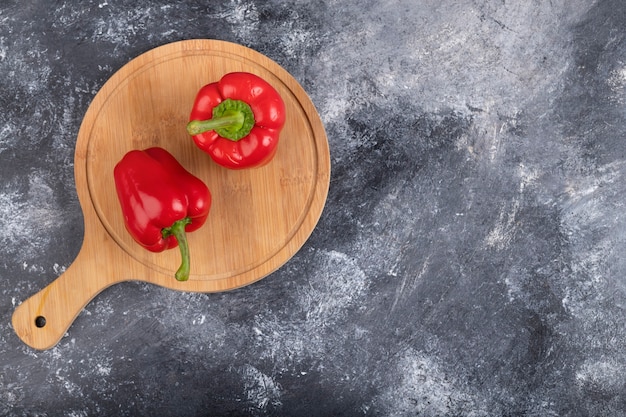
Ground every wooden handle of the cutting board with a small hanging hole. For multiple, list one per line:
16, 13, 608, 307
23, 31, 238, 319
12, 245, 122, 350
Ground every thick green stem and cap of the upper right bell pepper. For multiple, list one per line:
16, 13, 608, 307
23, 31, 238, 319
187, 98, 255, 141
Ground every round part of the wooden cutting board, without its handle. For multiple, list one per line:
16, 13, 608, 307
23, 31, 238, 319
85, 40, 330, 291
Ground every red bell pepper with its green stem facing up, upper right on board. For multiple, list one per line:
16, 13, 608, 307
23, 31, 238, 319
187, 72, 285, 169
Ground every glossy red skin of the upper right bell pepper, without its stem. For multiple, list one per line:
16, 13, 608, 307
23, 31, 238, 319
188, 72, 285, 169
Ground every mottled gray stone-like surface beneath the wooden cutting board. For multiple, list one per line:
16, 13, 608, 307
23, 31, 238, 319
0, 0, 626, 416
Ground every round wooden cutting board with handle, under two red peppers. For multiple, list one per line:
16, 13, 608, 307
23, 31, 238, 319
13, 40, 330, 349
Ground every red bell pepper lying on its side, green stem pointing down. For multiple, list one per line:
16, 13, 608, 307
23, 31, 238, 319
113, 147, 211, 281
